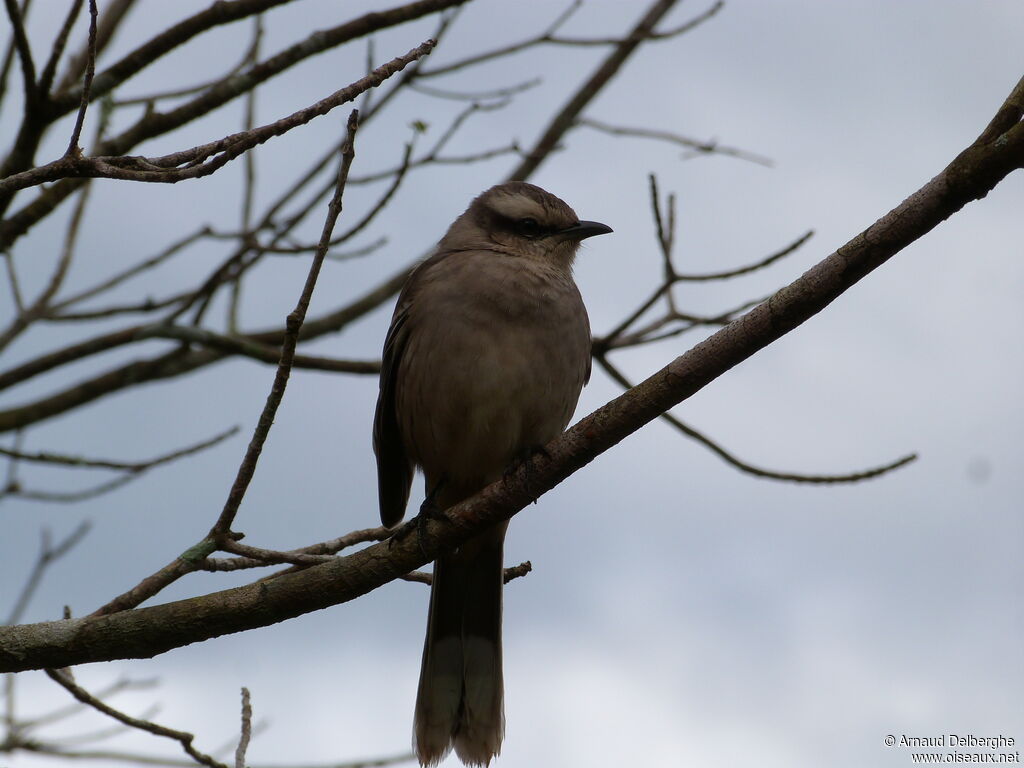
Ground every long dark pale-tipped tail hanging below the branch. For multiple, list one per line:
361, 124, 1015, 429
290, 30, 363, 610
414, 526, 505, 766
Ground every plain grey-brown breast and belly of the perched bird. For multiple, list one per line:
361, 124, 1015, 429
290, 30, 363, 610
396, 252, 590, 486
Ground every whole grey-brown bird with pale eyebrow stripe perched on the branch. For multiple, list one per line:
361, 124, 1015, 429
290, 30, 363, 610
374, 182, 611, 765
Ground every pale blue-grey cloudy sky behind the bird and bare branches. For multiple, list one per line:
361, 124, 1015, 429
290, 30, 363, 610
0, 0, 1024, 768
